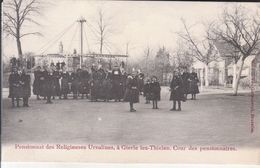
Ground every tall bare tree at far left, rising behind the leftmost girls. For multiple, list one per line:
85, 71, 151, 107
3, 0, 41, 59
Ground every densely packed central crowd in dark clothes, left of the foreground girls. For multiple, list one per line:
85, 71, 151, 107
33, 66, 146, 103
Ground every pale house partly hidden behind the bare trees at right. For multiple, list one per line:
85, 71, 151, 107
193, 40, 260, 87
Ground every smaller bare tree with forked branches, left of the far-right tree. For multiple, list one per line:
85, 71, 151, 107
178, 19, 218, 86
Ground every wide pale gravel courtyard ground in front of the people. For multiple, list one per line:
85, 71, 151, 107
2, 90, 260, 147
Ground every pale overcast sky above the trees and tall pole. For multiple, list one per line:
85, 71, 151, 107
2, 0, 259, 60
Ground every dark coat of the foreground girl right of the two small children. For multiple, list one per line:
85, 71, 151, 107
170, 76, 185, 101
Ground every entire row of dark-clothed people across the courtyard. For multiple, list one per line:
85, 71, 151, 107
9, 61, 199, 112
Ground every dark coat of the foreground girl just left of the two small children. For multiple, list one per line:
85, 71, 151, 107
124, 77, 139, 103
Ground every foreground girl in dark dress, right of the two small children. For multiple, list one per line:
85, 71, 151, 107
170, 72, 185, 111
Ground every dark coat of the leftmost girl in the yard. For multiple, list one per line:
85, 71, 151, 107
8, 73, 22, 98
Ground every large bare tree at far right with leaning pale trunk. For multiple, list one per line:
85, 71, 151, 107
213, 6, 260, 95
